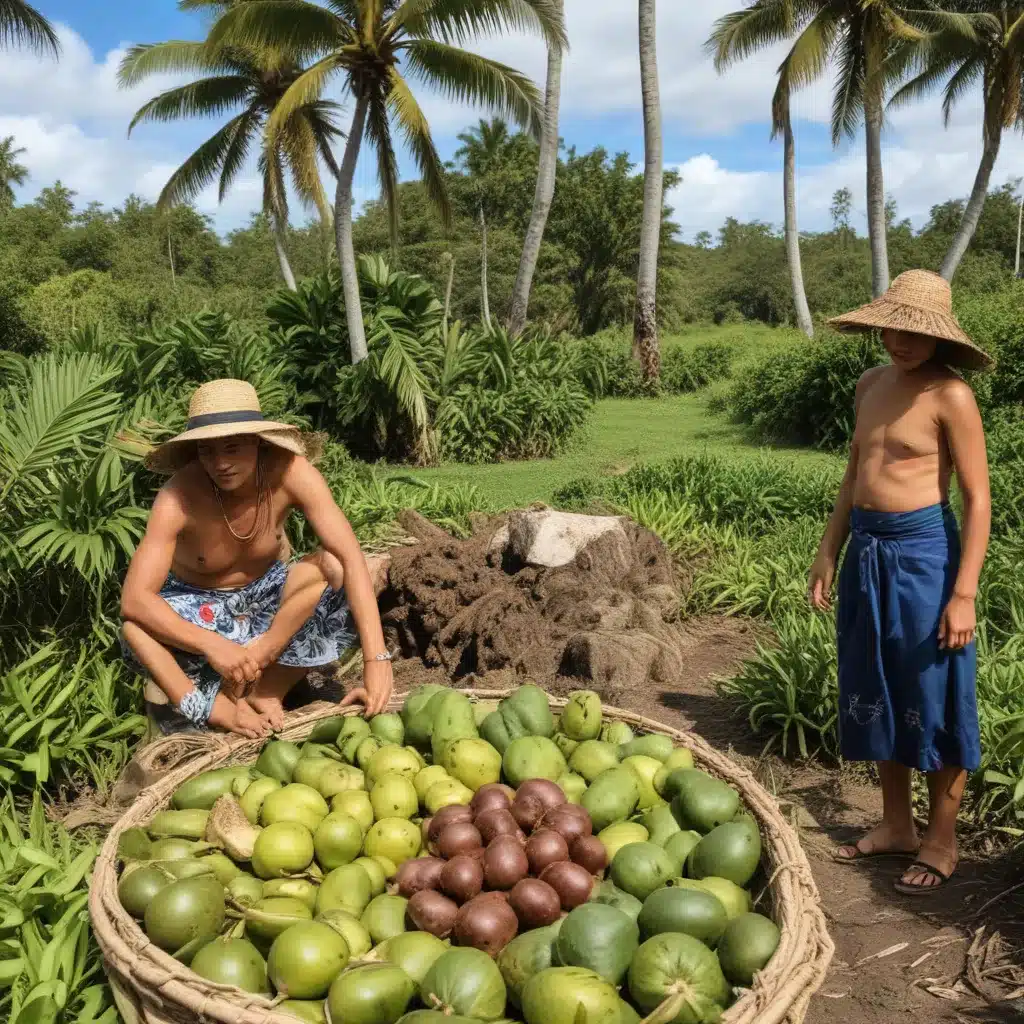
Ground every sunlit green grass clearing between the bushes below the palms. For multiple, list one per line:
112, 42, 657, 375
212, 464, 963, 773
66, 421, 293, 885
388, 325, 835, 508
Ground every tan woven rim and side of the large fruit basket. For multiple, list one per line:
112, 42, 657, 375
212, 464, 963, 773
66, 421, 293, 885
89, 690, 834, 1024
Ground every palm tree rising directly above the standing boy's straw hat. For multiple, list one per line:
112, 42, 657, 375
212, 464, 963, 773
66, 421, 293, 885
709, 0, 925, 296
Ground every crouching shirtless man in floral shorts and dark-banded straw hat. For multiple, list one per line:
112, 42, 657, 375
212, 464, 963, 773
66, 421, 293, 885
121, 380, 392, 738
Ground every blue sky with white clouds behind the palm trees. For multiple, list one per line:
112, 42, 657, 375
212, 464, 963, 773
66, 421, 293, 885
0, 0, 1024, 240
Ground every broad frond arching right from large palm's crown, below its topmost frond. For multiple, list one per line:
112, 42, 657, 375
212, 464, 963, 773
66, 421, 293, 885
407, 39, 544, 135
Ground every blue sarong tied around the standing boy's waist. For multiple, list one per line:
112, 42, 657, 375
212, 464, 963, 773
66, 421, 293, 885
837, 504, 981, 771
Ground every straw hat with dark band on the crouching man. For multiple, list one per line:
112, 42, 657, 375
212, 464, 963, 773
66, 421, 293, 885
145, 380, 319, 474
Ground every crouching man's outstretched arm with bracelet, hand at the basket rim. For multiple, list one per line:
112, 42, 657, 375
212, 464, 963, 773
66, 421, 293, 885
284, 458, 393, 715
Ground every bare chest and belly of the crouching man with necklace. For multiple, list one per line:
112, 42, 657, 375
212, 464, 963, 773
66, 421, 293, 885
167, 457, 292, 590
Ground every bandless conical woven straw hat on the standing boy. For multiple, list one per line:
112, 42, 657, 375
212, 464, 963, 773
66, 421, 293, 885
828, 270, 995, 370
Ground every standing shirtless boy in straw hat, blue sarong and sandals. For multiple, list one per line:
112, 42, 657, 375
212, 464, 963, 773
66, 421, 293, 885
809, 270, 991, 895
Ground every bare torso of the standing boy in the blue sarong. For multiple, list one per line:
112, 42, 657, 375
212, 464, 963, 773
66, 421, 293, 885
853, 366, 959, 512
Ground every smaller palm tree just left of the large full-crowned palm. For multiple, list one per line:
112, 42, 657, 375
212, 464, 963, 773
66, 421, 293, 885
118, 24, 341, 291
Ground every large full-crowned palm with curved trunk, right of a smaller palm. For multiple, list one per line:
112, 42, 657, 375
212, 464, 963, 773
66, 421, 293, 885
210, 0, 565, 362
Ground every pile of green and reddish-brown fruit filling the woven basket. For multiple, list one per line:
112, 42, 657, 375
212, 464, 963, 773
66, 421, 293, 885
118, 685, 779, 1024
